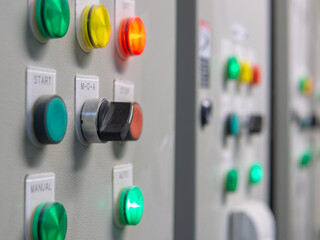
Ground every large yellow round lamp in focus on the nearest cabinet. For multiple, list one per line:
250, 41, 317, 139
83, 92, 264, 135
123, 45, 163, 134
82, 4, 111, 50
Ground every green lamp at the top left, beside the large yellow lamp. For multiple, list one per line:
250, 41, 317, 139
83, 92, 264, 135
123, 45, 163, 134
35, 0, 70, 39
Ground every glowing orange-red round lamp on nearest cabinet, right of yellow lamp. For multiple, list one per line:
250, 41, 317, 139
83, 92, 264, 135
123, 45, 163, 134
119, 17, 147, 58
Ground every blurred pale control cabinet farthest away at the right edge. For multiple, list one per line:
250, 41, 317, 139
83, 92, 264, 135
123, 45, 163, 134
272, 0, 318, 240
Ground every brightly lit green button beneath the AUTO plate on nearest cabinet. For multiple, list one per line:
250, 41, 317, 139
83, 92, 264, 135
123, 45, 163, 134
119, 186, 144, 225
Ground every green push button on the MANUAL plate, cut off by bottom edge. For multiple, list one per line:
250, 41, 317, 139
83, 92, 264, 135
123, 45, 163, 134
32, 202, 68, 240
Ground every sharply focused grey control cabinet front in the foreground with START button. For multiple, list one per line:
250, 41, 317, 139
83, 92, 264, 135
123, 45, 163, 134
0, 0, 176, 240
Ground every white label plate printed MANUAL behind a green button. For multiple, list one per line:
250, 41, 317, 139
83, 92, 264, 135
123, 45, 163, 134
24, 173, 55, 240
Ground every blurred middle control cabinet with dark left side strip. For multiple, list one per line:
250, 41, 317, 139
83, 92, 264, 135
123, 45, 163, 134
175, 0, 276, 240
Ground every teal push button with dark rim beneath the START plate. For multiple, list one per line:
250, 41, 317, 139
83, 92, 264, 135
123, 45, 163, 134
33, 95, 68, 144
